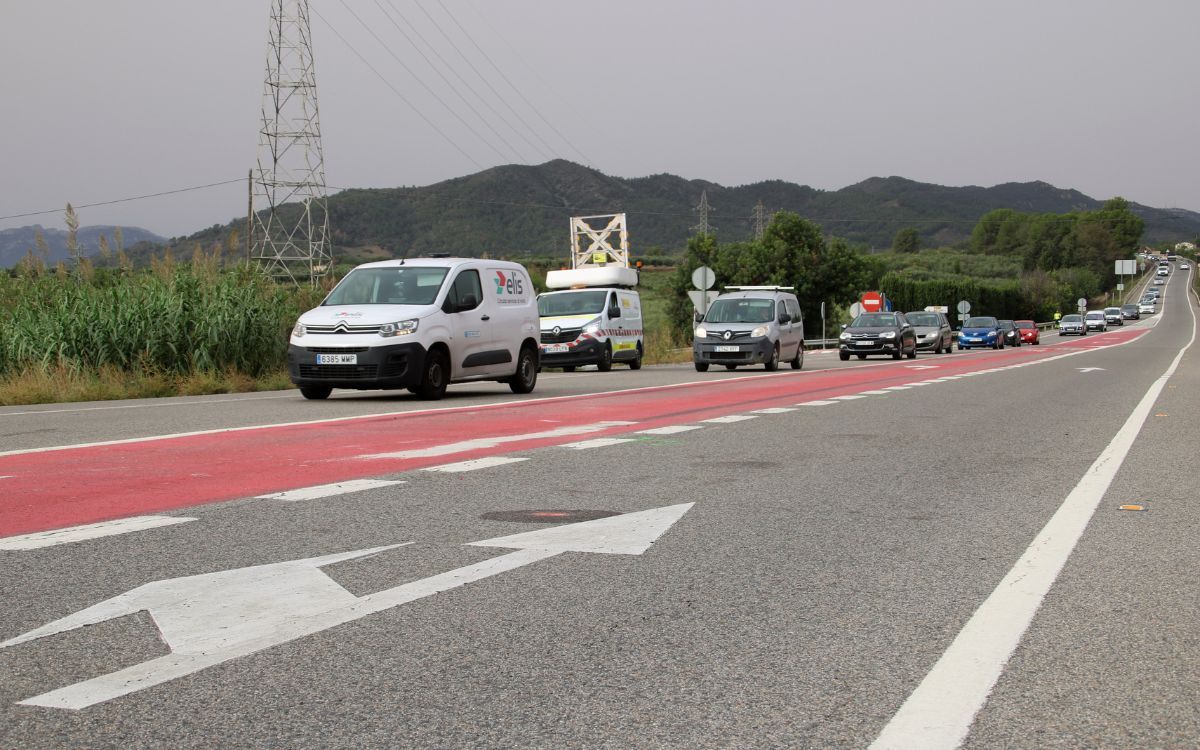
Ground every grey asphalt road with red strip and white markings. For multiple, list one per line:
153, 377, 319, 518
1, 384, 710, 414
0, 267, 1200, 749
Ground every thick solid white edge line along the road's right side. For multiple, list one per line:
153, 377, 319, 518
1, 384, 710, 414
871, 278, 1196, 750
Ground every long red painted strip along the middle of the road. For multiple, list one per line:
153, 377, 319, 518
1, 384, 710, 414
0, 329, 1146, 538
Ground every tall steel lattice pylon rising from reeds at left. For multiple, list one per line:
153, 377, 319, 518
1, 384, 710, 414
251, 0, 332, 283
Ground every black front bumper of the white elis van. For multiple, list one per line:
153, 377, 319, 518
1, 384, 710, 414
288, 343, 425, 390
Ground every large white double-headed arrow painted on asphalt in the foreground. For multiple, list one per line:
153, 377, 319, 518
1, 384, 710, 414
0, 503, 694, 710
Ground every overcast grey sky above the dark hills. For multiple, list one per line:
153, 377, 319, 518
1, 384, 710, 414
0, 0, 1200, 235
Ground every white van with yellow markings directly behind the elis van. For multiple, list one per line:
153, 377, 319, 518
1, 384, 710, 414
538, 282, 646, 372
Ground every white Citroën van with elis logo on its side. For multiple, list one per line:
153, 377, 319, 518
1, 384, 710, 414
288, 258, 539, 398
